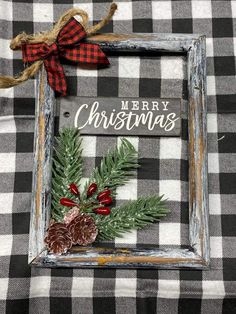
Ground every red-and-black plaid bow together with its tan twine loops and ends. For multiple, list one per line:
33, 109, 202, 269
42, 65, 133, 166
0, 3, 117, 96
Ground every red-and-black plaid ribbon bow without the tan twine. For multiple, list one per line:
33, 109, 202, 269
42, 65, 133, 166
22, 18, 109, 96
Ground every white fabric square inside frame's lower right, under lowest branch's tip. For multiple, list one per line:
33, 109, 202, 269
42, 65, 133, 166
159, 222, 180, 245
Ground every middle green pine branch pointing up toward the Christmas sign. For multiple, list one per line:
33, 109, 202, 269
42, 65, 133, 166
82, 138, 139, 199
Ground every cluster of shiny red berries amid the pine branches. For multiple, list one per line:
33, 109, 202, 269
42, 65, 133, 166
60, 183, 113, 215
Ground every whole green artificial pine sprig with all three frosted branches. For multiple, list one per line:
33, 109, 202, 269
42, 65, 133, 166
52, 128, 169, 240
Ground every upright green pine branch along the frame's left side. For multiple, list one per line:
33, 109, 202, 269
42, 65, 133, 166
52, 128, 83, 221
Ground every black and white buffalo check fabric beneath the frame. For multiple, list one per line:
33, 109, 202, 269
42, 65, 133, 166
0, 0, 236, 314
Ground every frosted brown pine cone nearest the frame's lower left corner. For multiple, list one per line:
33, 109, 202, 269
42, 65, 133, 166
44, 222, 72, 254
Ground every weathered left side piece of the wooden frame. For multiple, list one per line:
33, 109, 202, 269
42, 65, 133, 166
29, 69, 54, 263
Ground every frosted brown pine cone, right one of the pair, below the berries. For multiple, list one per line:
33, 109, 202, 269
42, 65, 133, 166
67, 214, 98, 246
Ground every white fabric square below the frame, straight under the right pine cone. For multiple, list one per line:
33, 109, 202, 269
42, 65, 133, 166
71, 277, 93, 298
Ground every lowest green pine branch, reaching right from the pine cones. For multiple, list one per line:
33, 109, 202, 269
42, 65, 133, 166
94, 196, 170, 240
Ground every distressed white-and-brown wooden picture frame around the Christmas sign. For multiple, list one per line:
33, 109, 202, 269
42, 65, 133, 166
29, 34, 210, 269
